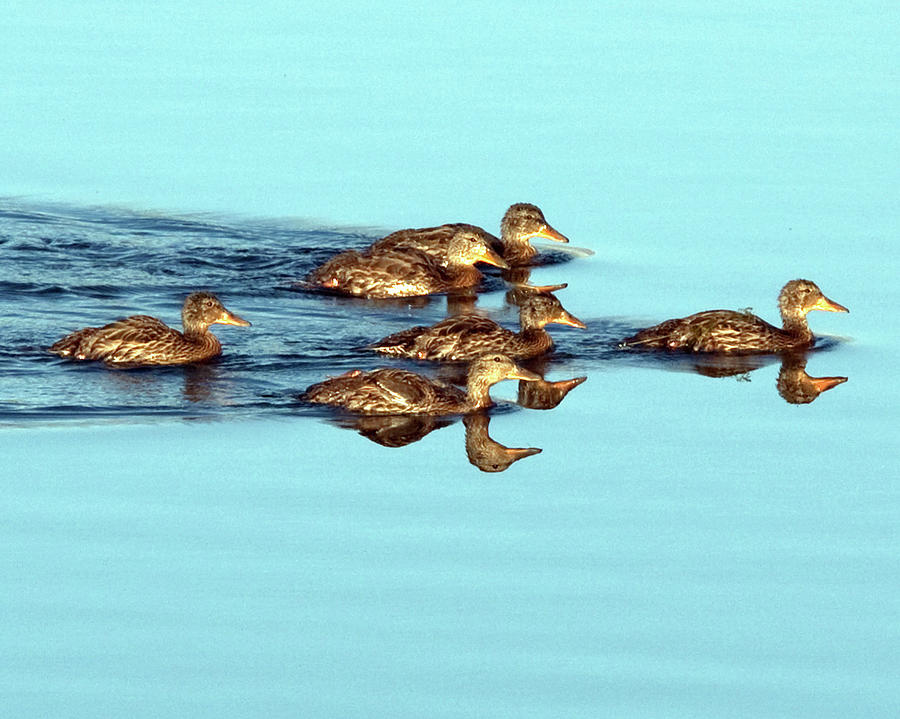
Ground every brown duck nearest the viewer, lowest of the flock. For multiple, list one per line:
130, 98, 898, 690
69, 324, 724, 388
301, 353, 540, 415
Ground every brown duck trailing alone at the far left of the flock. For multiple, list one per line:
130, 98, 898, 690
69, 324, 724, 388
49, 292, 250, 367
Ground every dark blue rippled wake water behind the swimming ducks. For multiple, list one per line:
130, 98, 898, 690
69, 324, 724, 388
0, 200, 596, 423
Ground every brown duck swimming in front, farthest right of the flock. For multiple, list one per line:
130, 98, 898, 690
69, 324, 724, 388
620, 279, 850, 353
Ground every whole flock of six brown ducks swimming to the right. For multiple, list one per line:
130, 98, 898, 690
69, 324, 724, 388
50, 203, 849, 415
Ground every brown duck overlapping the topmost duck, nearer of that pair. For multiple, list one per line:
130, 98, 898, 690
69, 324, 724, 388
309, 228, 508, 298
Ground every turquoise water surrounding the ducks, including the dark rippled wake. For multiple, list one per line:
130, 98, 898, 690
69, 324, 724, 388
0, 2, 900, 717
